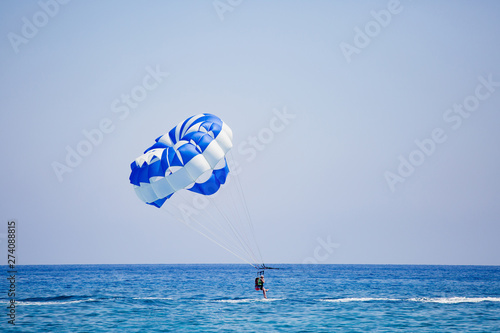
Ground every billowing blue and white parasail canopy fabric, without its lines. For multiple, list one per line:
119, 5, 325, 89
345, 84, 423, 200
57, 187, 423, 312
130, 113, 233, 208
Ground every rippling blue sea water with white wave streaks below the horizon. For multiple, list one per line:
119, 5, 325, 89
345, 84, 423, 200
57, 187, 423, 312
0, 265, 500, 332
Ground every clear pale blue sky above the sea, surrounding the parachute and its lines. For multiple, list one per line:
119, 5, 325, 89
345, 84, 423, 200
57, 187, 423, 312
0, 0, 500, 265
